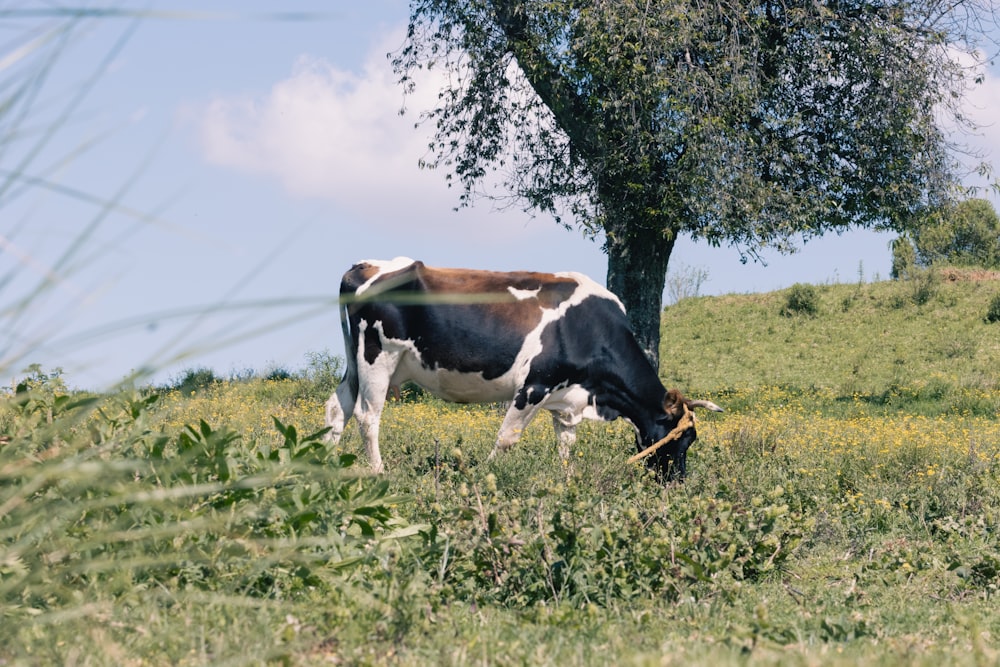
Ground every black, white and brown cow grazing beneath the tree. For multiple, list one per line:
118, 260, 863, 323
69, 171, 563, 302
326, 257, 722, 479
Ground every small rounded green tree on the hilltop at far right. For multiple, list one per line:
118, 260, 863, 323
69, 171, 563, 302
911, 199, 1000, 269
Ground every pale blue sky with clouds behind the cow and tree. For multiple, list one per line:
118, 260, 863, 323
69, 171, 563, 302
0, 0, 1000, 390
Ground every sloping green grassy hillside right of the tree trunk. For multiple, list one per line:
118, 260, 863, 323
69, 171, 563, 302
660, 273, 1000, 396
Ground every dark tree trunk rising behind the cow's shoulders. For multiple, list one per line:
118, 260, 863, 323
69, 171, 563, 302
605, 220, 676, 372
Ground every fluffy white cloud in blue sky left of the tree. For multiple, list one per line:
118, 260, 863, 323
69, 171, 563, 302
199, 35, 524, 235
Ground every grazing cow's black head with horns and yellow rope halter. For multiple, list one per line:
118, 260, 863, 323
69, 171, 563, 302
632, 389, 723, 481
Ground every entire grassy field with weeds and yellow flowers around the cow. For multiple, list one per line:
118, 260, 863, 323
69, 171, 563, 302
0, 276, 1000, 665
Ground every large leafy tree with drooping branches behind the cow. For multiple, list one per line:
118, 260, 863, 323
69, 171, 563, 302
393, 0, 992, 364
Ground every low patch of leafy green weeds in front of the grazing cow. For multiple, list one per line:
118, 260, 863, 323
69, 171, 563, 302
414, 476, 813, 608
